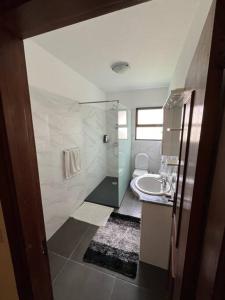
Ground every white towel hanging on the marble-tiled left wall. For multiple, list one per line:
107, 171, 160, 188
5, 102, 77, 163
64, 148, 81, 179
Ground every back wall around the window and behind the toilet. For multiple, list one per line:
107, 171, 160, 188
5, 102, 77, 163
107, 87, 168, 173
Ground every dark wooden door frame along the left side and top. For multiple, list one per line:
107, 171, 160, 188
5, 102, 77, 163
0, 0, 224, 300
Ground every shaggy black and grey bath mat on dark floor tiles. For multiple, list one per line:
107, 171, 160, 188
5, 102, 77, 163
84, 212, 140, 278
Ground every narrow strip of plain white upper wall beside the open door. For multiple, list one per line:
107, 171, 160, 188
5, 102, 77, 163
169, 0, 213, 90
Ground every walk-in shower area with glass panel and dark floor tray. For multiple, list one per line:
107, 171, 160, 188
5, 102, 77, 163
80, 100, 131, 208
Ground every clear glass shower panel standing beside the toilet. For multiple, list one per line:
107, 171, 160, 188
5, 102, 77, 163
118, 104, 131, 206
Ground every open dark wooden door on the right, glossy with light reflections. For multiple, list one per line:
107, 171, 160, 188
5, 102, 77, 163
173, 0, 225, 300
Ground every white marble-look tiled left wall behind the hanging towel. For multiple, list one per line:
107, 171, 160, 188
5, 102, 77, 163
30, 87, 110, 238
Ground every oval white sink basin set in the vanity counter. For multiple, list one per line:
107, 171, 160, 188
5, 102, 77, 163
135, 174, 170, 196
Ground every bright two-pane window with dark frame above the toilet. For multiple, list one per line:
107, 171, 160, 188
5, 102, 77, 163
136, 107, 163, 140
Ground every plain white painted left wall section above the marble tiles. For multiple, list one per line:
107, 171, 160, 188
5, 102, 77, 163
24, 39, 105, 102
